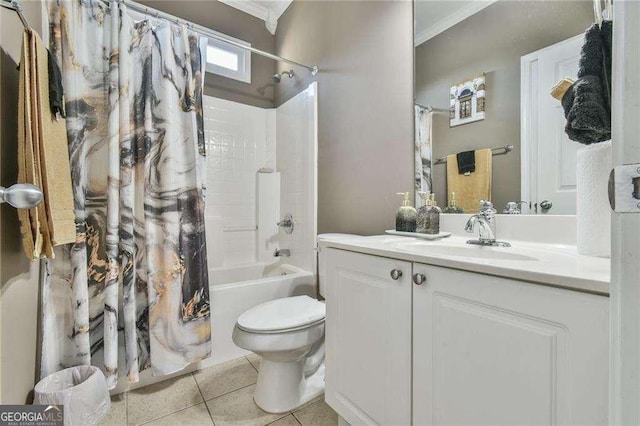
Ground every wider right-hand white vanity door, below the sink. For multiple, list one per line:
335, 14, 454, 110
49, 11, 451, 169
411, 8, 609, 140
413, 264, 609, 425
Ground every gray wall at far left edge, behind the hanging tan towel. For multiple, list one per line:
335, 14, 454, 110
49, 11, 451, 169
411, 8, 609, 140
0, 1, 41, 404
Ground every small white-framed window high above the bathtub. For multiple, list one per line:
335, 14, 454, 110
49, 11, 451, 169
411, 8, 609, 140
207, 34, 251, 83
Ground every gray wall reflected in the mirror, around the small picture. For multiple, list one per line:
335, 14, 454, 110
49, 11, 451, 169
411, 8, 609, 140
415, 0, 593, 209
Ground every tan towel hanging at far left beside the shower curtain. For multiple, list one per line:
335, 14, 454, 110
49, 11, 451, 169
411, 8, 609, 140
18, 30, 76, 259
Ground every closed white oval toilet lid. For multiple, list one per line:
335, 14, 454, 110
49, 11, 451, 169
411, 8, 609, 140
238, 296, 325, 333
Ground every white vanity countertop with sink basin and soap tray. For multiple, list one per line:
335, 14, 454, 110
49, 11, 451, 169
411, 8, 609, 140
318, 234, 611, 296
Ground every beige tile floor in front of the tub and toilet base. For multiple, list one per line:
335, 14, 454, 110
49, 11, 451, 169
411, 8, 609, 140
101, 355, 338, 426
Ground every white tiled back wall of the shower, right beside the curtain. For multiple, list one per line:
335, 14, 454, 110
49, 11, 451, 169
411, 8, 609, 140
203, 96, 276, 267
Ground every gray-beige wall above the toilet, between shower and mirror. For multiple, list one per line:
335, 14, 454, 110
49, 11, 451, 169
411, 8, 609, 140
276, 0, 413, 234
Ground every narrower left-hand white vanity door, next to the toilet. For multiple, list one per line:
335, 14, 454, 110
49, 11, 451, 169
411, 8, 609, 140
324, 249, 411, 425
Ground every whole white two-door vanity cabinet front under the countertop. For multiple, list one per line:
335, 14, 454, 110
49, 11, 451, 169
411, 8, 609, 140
323, 248, 609, 425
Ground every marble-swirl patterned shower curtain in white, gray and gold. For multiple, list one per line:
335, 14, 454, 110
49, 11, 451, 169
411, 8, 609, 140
41, 0, 211, 387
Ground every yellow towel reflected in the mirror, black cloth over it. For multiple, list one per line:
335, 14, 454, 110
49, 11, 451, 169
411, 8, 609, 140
447, 149, 493, 213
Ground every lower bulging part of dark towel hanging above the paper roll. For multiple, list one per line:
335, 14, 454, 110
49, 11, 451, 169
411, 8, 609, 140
562, 75, 611, 145
